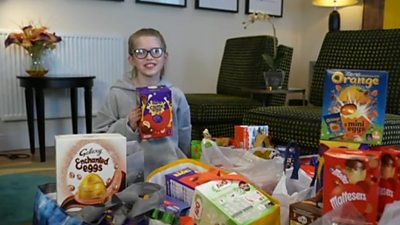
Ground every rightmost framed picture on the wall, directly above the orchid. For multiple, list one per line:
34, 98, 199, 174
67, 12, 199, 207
245, 0, 283, 17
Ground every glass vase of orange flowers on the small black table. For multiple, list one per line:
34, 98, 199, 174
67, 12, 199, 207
4, 25, 61, 76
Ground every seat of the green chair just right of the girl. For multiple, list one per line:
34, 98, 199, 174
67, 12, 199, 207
186, 94, 262, 124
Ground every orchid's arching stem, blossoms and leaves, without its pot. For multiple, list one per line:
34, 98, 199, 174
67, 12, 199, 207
243, 12, 283, 71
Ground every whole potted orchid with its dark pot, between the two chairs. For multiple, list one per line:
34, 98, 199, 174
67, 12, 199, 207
243, 12, 285, 90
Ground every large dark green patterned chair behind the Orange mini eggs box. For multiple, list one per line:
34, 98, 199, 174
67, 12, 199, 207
243, 29, 400, 154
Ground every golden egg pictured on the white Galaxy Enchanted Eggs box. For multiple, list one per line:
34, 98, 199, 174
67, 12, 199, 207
77, 173, 107, 203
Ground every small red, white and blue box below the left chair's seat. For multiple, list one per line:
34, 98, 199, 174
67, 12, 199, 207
233, 125, 269, 150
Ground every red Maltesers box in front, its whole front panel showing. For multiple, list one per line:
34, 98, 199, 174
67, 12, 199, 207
323, 148, 381, 225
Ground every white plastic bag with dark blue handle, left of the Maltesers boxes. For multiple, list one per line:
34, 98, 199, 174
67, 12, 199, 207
272, 142, 315, 225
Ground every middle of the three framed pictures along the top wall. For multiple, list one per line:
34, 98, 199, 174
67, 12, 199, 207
195, 0, 239, 13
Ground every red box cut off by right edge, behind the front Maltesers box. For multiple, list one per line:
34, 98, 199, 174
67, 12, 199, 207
372, 145, 400, 217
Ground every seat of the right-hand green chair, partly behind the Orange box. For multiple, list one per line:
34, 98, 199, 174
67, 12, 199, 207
243, 106, 400, 155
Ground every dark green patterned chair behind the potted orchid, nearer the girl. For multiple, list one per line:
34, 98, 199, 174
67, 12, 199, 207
186, 36, 293, 139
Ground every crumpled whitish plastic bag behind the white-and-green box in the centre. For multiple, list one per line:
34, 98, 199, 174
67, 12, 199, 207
200, 139, 283, 193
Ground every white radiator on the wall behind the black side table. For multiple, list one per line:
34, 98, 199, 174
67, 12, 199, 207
0, 31, 126, 121
